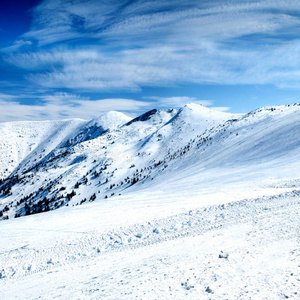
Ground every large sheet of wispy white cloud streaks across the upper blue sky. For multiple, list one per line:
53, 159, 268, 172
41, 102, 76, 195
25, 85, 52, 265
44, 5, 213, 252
2, 0, 300, 114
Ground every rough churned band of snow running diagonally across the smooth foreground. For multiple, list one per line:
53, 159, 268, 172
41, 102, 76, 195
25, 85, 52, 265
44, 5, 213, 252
0, 190, 300, 290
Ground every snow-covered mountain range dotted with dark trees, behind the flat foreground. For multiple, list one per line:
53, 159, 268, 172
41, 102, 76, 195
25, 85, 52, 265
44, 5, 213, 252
0, 103, 300, 219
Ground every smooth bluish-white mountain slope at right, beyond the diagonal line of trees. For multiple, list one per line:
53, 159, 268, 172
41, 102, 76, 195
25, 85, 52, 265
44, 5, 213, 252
149, 105, 300, 196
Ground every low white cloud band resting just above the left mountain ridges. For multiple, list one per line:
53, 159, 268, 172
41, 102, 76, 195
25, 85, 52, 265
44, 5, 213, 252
0, 93, 229, 122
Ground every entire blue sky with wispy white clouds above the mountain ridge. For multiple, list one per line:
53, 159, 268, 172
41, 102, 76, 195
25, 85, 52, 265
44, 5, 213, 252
0, 0, 300, 122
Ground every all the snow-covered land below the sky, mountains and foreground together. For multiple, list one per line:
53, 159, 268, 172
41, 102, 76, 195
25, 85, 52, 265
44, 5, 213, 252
0, 104, 300, 299
